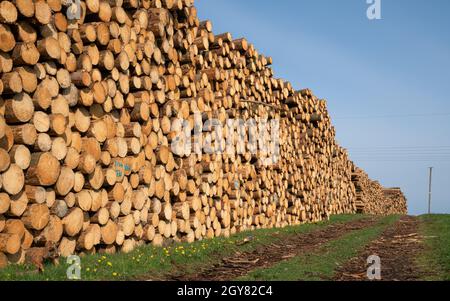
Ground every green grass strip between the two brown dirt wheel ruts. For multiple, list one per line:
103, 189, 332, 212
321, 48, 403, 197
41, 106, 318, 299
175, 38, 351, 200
238, 216, 399, 281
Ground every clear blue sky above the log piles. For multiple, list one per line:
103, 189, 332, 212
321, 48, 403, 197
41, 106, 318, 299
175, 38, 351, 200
196, 0, 450, 214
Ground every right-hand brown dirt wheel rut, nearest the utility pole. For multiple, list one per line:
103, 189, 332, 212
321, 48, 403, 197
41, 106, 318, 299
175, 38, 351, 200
334, 216, 423, 281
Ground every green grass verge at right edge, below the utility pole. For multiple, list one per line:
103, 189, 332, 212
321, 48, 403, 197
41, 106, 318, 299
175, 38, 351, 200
418, 215, 450, 281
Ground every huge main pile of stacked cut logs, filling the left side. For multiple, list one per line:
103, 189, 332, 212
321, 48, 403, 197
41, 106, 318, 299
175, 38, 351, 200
0, 0, 406, 263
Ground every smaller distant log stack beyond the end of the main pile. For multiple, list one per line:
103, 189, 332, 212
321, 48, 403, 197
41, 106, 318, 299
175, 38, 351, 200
352, 168, 408, 215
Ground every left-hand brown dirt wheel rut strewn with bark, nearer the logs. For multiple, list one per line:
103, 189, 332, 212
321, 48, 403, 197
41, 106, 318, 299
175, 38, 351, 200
162, 218, 379, 281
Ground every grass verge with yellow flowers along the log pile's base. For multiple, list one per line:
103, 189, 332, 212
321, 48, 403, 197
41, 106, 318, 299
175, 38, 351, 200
0, 215, 365, 281
